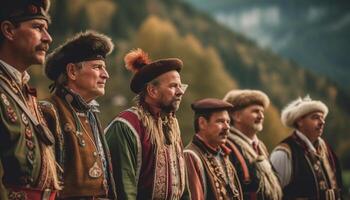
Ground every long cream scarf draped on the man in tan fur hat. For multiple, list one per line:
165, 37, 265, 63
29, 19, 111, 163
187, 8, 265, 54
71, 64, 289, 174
230, 134, 282, 200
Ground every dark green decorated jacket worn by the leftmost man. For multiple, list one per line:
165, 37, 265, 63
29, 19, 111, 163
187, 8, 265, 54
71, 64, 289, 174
0, 63, 54, 200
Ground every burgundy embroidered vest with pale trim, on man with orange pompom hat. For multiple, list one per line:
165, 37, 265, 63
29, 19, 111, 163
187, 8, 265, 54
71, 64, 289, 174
115, 108, 185, 199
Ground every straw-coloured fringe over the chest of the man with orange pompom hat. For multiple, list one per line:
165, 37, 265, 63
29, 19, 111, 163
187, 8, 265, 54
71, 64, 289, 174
135, 106, 181, 149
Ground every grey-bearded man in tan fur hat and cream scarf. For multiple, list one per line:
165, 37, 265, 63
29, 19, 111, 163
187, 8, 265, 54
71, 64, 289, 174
224, 90, 282, 200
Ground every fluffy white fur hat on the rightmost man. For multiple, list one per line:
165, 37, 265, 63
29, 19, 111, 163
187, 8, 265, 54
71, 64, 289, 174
281, 95, 328, 128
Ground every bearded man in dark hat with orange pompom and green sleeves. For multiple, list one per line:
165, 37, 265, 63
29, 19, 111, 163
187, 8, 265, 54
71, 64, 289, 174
105, 49, 189, 199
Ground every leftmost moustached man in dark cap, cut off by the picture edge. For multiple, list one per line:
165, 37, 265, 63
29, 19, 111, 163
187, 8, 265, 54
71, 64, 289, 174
0, 0, 60, 200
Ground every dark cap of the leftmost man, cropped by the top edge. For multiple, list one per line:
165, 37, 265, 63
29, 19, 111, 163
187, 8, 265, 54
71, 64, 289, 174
0, 0, 51, 22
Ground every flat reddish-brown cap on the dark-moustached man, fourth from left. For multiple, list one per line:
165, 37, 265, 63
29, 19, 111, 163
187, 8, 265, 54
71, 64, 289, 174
191, 98, 233, 113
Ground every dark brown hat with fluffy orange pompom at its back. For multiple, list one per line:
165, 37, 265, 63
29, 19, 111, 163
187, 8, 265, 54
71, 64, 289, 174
124, 48, 183, 94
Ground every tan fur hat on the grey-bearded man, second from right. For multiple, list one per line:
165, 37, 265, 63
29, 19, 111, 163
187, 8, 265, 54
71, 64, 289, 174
223, 90, 270, 111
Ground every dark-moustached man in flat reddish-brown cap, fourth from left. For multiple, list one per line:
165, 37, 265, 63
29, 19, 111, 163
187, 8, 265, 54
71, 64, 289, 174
184, 98, 243, 200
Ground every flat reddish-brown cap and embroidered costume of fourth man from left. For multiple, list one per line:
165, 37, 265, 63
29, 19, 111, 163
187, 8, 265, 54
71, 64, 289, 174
184, 98, 243, 200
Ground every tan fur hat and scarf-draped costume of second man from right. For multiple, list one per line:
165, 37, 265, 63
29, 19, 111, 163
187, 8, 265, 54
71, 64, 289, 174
224, 90, 282, 200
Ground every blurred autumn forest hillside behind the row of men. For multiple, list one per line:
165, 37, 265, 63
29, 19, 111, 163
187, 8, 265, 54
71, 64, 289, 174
31, 0, 350, 195
